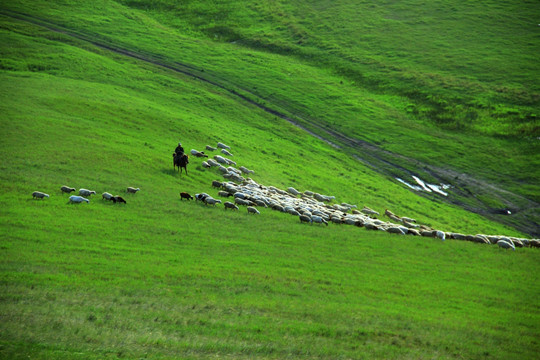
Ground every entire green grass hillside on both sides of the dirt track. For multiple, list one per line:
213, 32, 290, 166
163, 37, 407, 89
0, 1, 540, 359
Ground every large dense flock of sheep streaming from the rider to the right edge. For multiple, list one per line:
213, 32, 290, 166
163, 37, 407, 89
184, 143, 540, 250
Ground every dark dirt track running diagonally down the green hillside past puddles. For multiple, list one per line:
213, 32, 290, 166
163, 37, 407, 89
0, 10, 540, 237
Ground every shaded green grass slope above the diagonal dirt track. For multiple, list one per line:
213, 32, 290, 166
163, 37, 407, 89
5, 1, 540, 234
